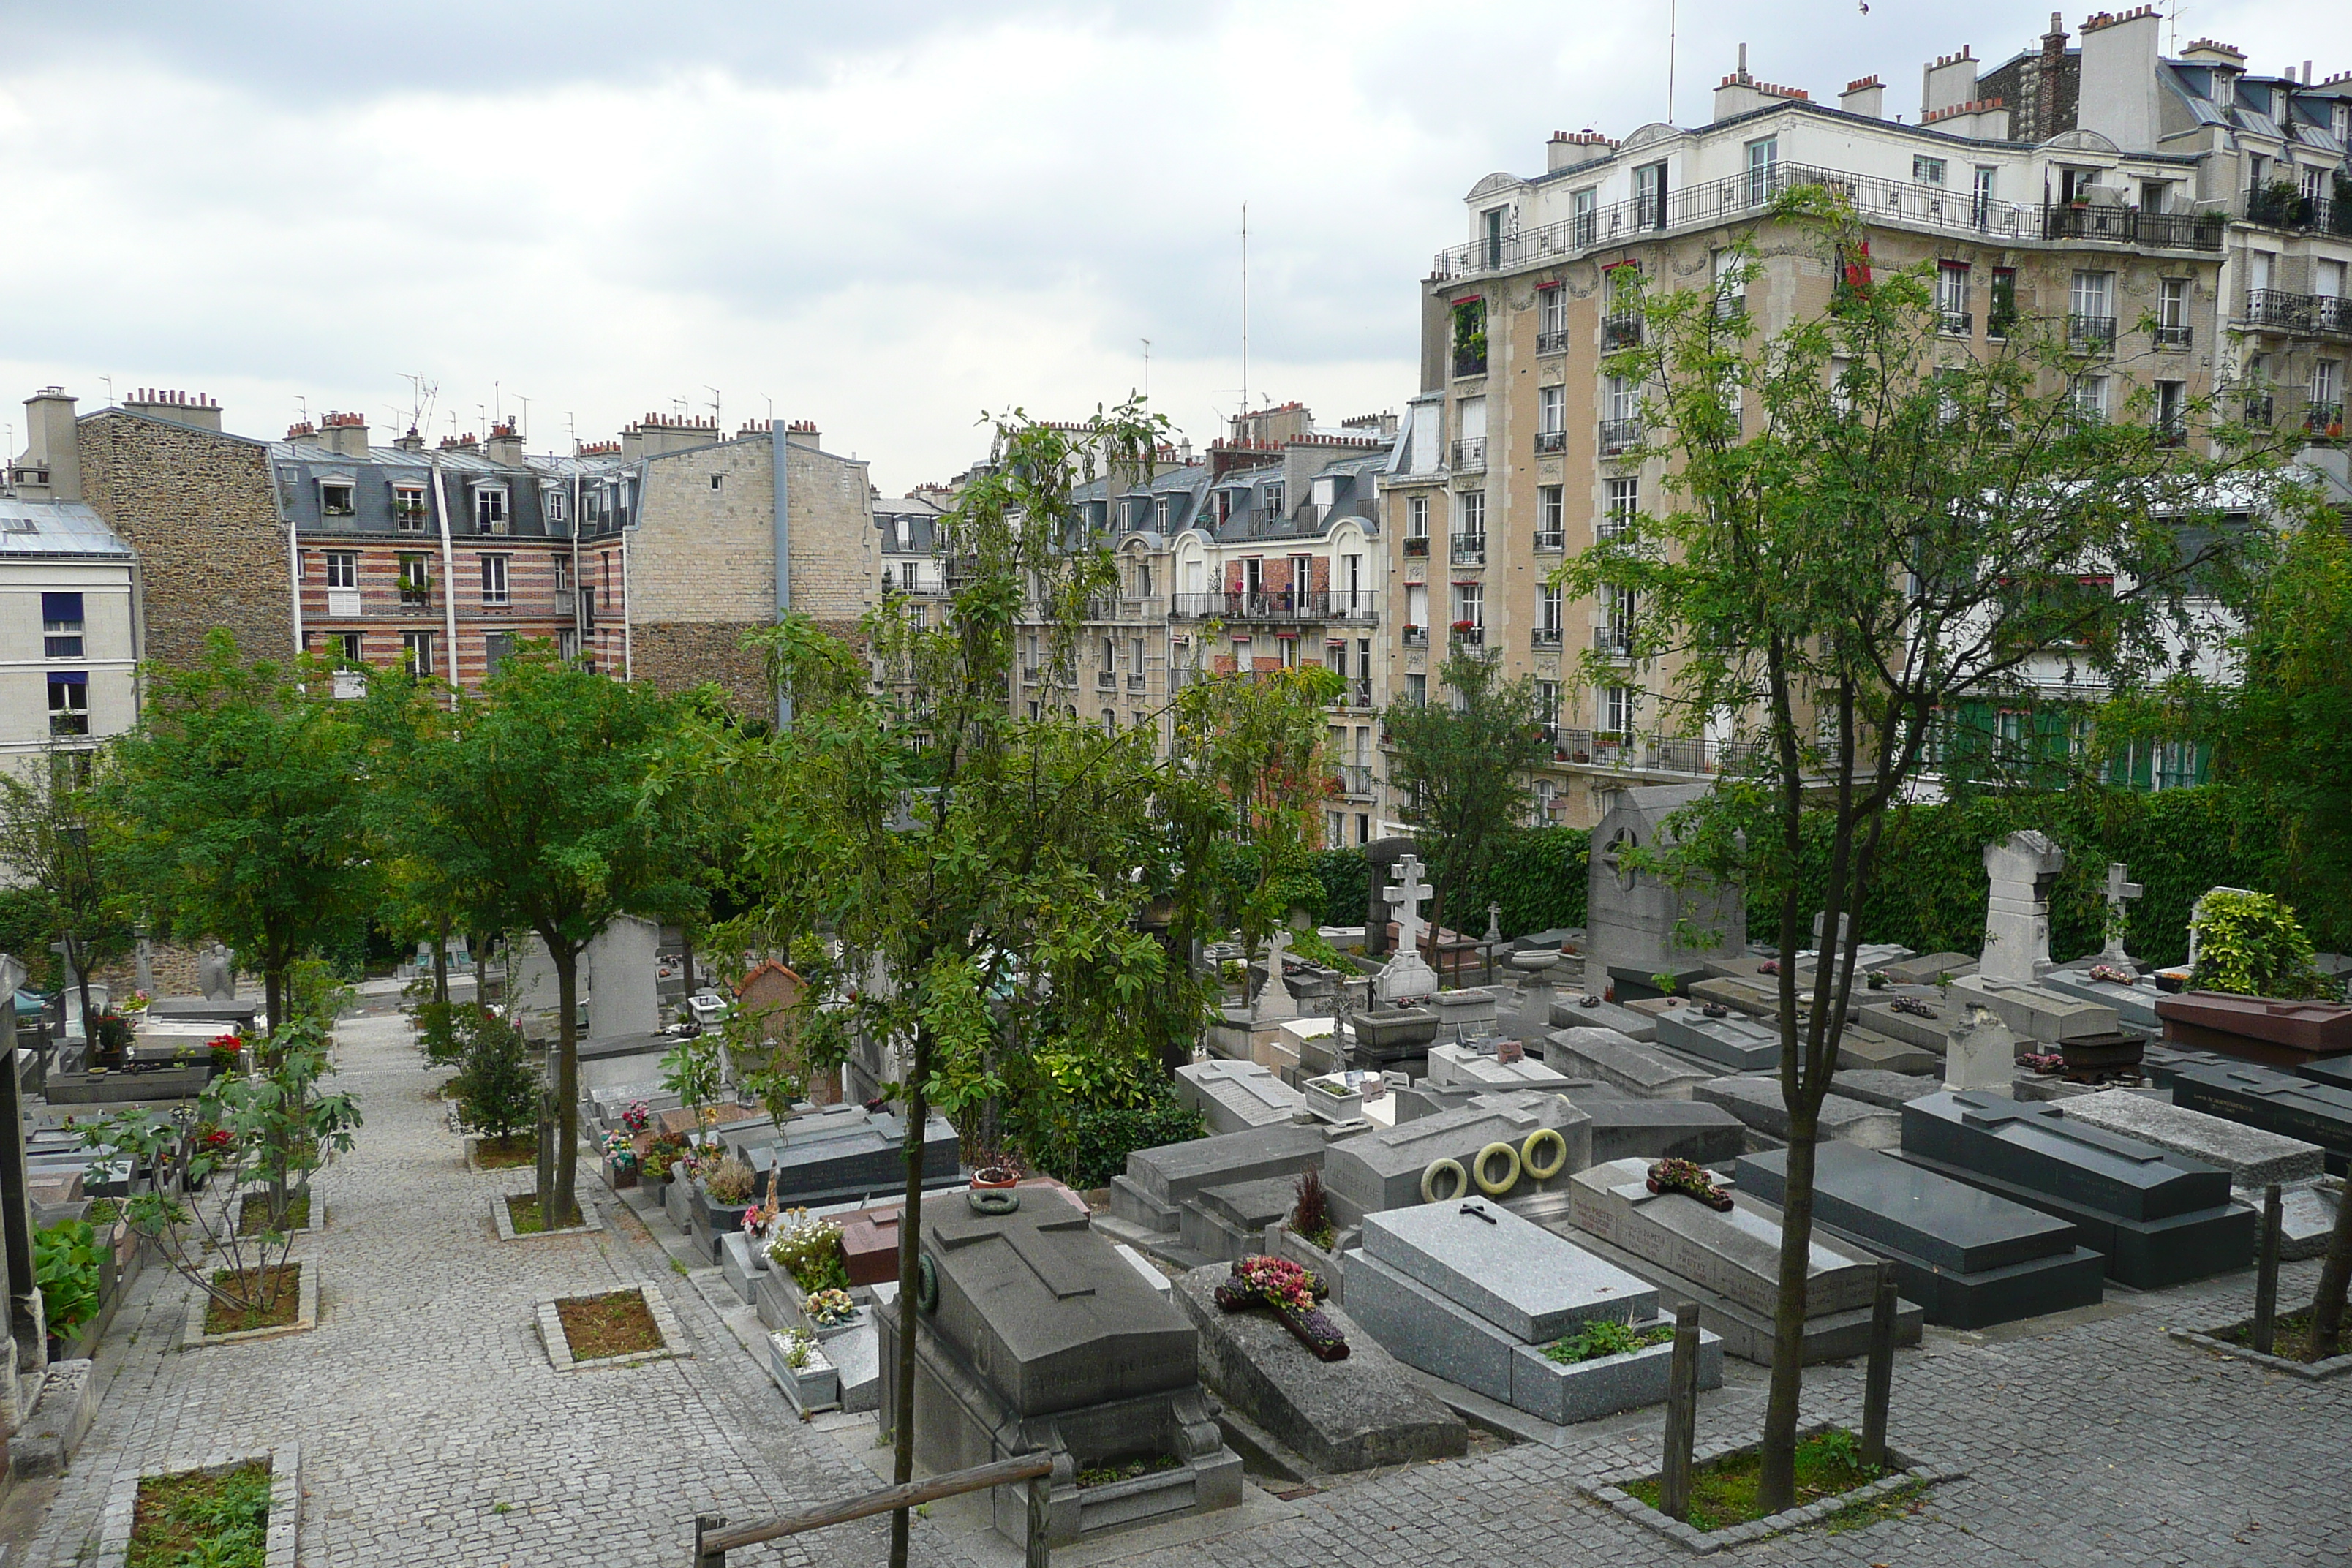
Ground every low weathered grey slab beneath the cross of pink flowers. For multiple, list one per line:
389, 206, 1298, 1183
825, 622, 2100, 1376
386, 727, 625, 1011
1174, 1264, 1470, 1474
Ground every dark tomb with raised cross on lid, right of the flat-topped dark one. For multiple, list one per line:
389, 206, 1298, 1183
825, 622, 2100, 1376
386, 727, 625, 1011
1903, 1093, 2255, 1291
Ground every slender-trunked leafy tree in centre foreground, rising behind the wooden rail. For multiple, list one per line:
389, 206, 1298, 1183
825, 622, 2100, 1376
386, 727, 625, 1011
704, 404, 1207, 1568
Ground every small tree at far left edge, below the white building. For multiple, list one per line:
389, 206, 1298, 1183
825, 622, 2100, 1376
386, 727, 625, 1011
0, 750, 120, 1060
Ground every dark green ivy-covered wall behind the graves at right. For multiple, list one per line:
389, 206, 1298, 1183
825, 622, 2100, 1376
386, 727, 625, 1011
1315, 785, 2352, 964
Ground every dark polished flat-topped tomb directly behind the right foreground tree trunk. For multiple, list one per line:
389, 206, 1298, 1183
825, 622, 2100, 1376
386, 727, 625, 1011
1733, 1142, 2108, 1328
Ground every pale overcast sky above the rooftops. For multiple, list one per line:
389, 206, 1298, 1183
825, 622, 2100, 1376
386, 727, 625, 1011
0, 0, 2352, 491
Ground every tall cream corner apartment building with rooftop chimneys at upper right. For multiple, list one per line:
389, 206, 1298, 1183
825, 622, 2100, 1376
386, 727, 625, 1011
1381, 7, 2352, 825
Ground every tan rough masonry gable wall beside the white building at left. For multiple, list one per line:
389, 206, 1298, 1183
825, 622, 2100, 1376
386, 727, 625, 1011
78, 412, 294, 663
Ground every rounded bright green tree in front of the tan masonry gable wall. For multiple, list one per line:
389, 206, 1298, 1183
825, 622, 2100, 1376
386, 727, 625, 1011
106, 630, 377, 1048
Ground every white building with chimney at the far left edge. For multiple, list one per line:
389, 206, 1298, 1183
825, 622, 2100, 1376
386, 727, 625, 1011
0, 388, 139, 766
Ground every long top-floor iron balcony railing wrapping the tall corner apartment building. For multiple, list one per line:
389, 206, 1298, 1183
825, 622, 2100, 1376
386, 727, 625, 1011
1430, 162, 2220, 282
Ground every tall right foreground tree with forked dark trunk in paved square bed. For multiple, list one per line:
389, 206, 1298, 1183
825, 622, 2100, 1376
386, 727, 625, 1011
1557, 188, 2272, 1507
